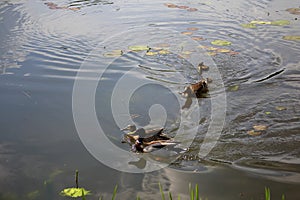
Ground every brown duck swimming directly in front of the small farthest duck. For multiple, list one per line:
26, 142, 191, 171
181, 79, 208, 98
